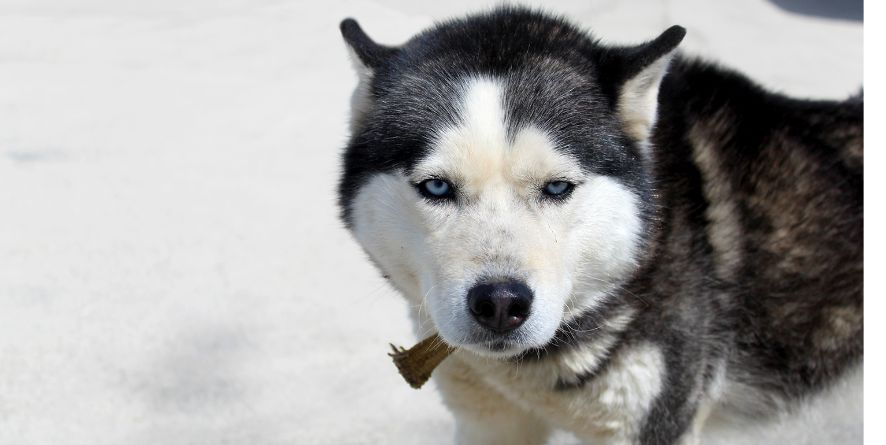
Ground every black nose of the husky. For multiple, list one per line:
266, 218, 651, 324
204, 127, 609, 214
468, 280, 532, 333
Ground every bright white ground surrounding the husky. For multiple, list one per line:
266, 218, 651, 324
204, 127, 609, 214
0, 0, 862, 444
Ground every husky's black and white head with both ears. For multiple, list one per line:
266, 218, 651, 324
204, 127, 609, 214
340, 8, 685, 357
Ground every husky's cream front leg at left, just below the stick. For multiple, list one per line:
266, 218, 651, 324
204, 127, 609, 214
434, 356, 550, 445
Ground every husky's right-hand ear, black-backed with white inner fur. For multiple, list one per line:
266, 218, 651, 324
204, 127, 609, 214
597, 26, 686, 142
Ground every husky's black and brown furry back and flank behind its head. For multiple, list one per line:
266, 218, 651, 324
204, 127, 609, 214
656, 60, 864, 409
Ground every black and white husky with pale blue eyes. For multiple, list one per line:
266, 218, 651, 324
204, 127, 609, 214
339, 7, 863, 444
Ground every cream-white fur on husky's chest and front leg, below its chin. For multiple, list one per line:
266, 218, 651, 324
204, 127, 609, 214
435, 343, 664, 444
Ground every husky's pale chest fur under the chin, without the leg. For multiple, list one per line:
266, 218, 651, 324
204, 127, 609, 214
444, 342, 664, 437
